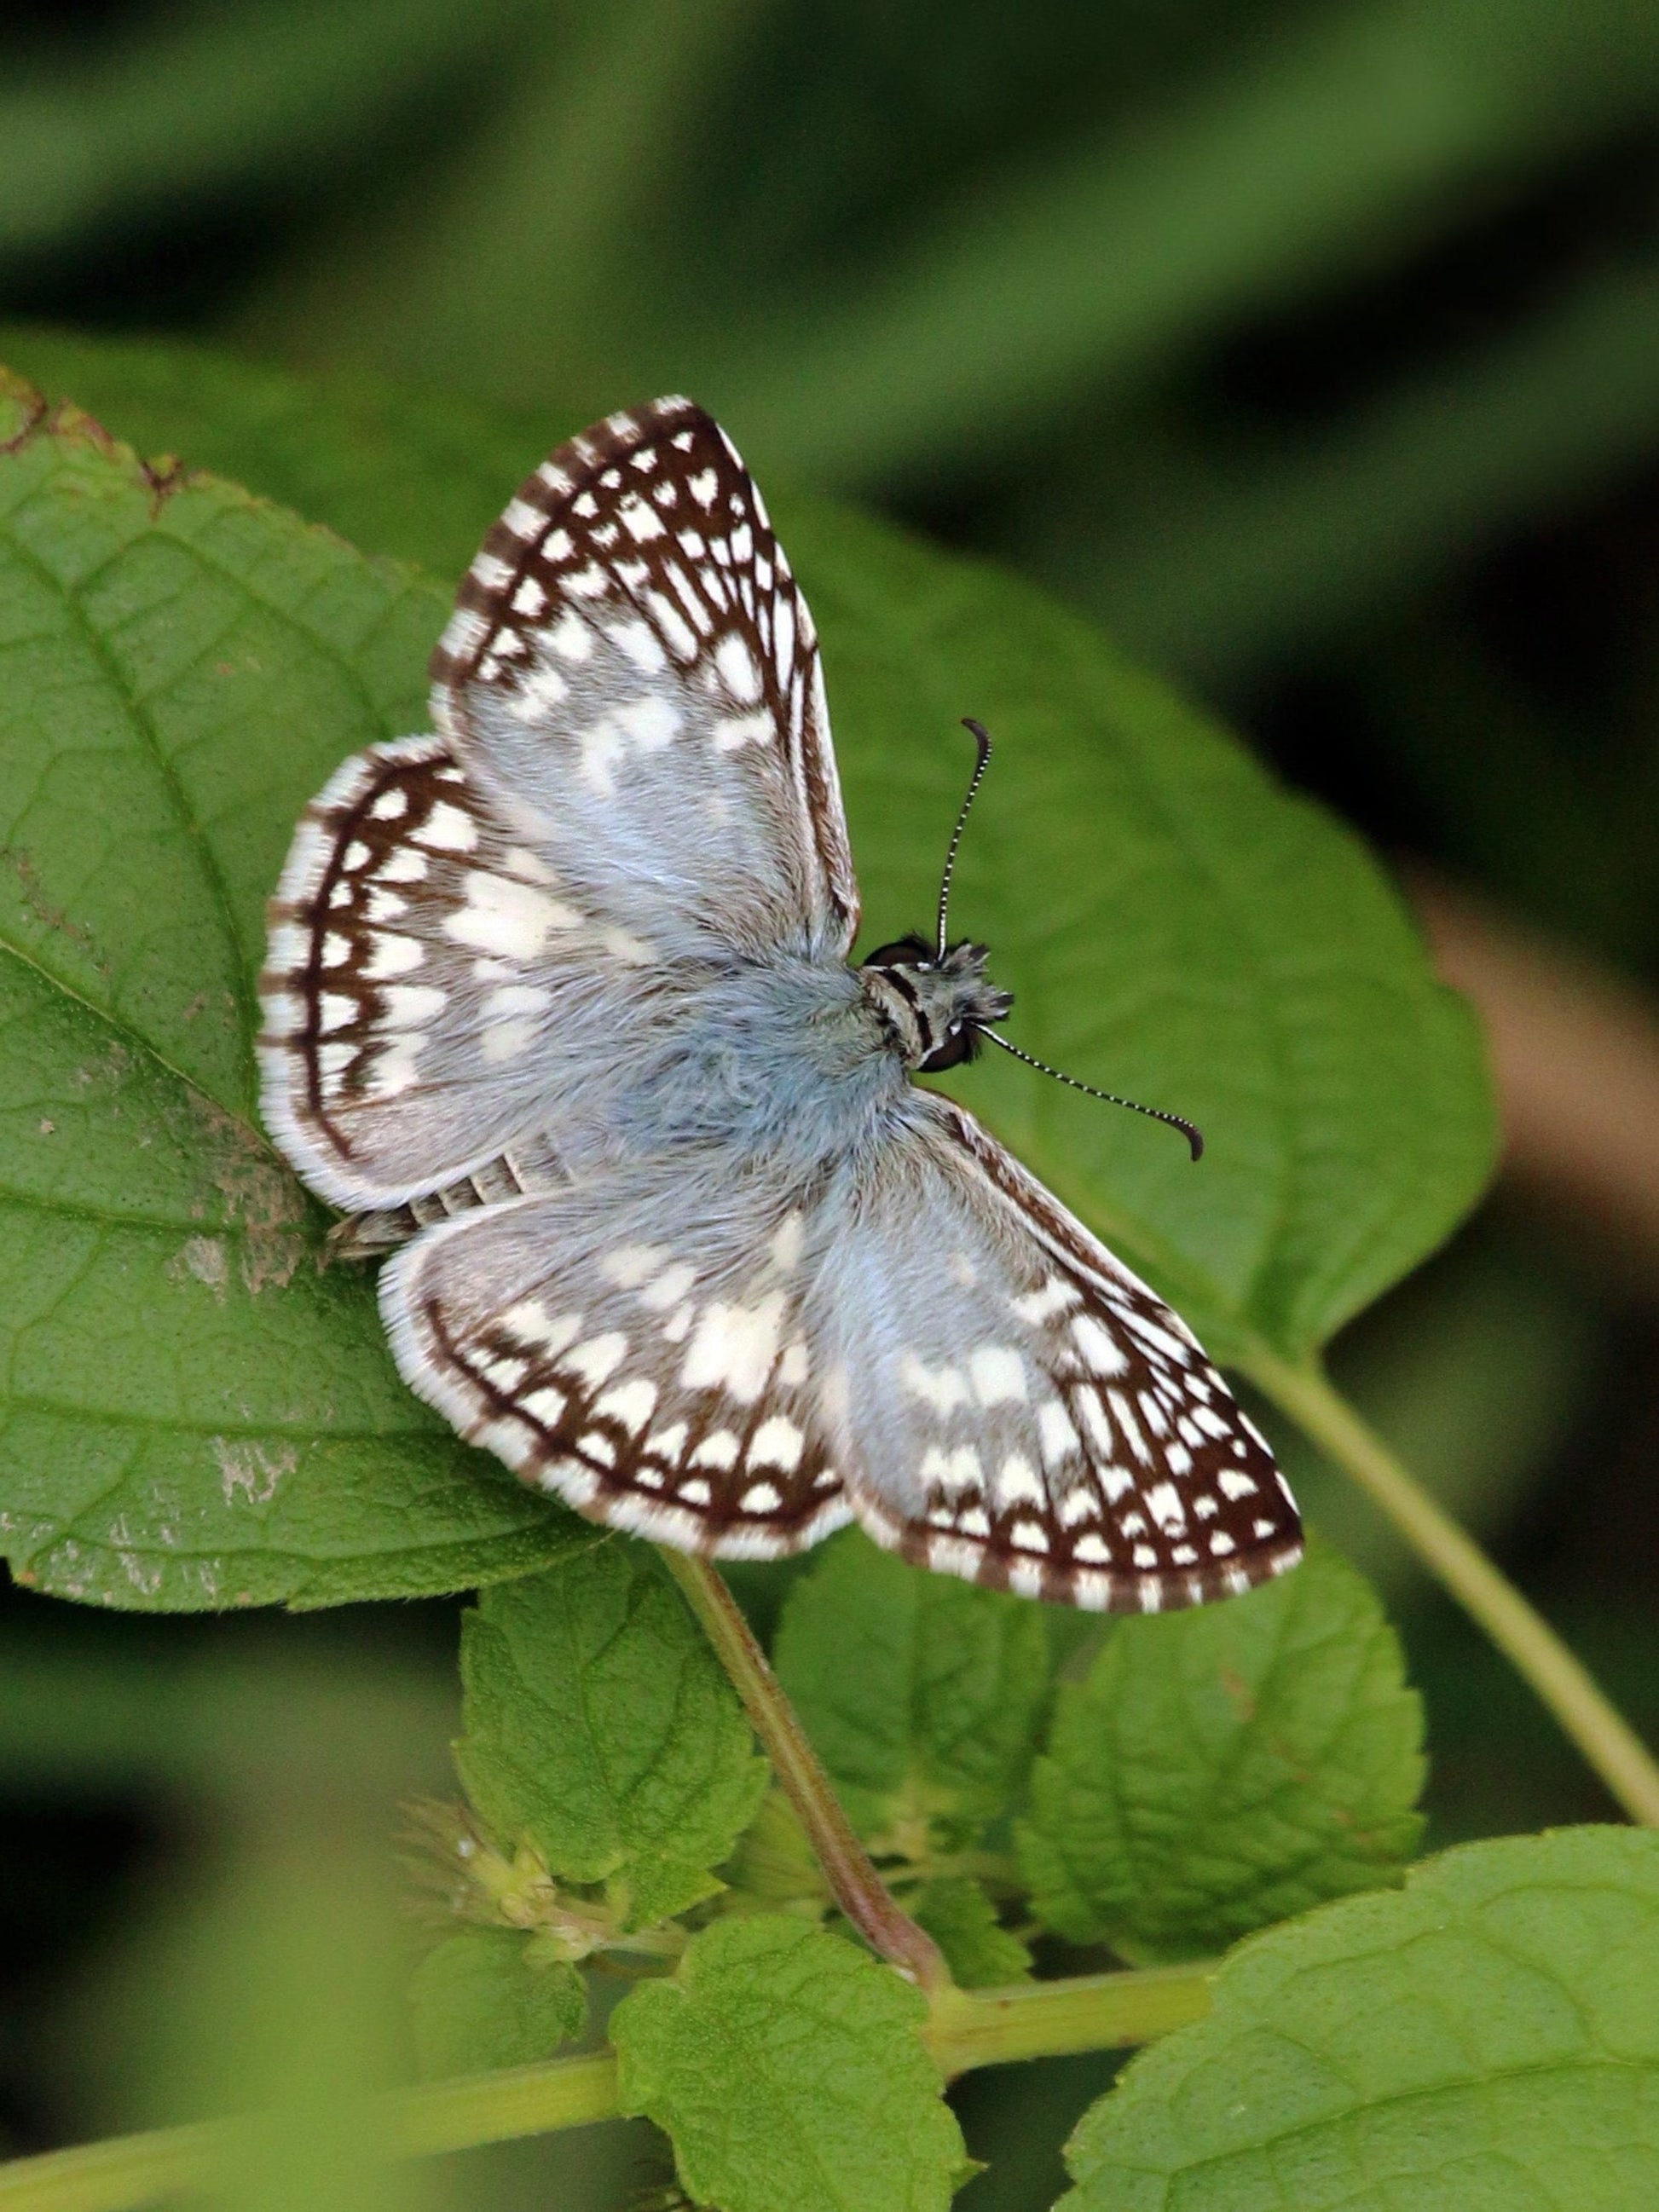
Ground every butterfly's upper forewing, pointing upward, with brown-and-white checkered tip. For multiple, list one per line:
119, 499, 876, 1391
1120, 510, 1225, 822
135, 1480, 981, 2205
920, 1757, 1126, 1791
431, 398, 858, 958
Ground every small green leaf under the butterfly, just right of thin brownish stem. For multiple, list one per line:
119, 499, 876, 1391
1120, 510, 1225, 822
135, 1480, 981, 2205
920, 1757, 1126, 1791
772, 1531, 1049, 1858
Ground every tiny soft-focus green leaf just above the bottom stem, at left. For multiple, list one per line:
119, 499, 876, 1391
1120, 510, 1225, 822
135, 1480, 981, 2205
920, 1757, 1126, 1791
409, 1929, 588, 2082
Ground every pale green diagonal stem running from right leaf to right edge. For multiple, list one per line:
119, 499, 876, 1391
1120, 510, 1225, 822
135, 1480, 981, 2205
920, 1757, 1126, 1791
1246, 1352, 1659, 1827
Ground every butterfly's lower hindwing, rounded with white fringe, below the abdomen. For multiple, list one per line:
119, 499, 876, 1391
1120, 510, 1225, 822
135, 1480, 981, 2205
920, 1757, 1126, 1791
380, 1159, 849, 1559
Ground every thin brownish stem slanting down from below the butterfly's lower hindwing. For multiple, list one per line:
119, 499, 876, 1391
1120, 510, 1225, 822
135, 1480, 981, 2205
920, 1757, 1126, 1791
657, 1544, 951, 1993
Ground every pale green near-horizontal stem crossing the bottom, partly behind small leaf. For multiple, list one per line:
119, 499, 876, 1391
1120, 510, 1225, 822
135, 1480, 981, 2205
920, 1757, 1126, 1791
0, 1960, 1214, 2212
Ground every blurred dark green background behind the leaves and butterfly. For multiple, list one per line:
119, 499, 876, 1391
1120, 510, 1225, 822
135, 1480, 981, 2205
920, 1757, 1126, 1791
0, 0, 1659, 2212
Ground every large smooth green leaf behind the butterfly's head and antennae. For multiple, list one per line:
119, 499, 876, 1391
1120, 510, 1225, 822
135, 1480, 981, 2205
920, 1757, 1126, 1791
15, 332, 1493, 1356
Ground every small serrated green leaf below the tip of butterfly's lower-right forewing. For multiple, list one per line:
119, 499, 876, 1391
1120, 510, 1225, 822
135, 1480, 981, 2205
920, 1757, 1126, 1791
1020, 1546, 1425, 1962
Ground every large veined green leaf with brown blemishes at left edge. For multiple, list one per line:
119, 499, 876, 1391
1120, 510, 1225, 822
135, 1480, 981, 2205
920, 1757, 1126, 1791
0, 371, 577, 1610
